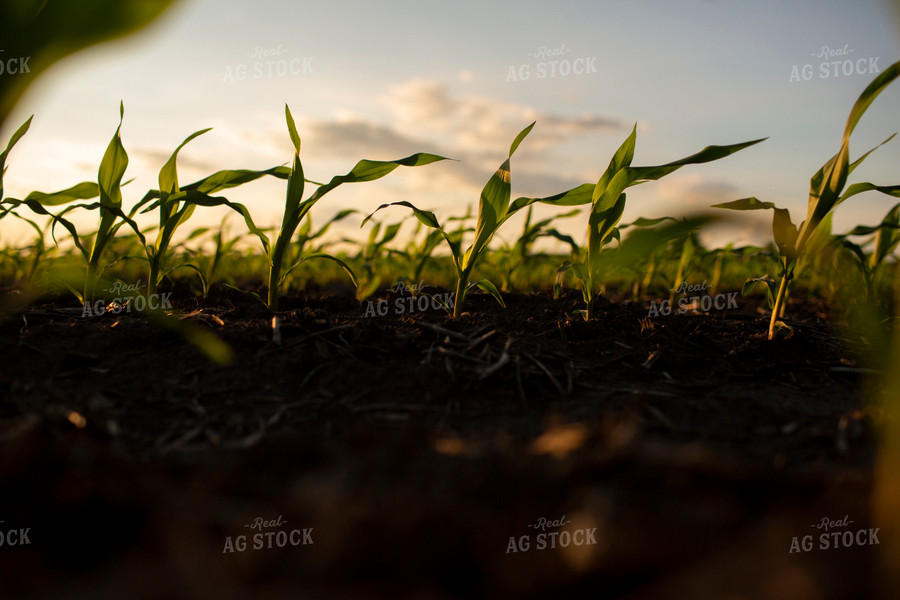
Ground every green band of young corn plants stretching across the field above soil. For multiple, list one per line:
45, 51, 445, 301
0, 63, 900, 360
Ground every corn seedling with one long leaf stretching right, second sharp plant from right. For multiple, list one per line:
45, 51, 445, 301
560, 125, 765, 320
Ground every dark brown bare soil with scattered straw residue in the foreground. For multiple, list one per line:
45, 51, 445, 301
0, 288, 887, 599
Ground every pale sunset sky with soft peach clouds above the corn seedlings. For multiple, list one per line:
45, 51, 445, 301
0, 0, 900, 248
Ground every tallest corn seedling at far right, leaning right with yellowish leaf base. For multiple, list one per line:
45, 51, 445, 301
715, 62, 900, 340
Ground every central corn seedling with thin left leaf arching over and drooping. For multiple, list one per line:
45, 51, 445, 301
363, 123, 590, 319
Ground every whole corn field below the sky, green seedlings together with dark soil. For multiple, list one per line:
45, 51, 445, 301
0, 10, 900, 599
